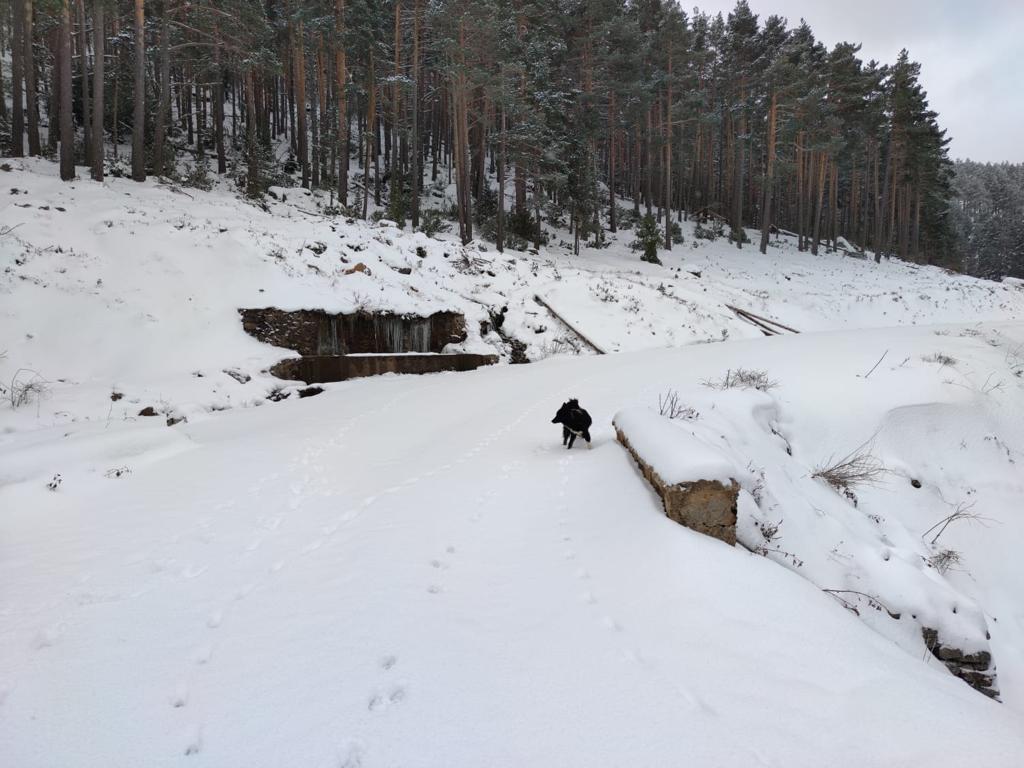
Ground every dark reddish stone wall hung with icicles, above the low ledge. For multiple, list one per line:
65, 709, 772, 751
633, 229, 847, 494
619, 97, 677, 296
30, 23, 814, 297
239, 307, 467, 355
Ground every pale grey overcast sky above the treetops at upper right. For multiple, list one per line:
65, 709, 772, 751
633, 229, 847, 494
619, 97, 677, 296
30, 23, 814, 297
696, 0, 1024, 163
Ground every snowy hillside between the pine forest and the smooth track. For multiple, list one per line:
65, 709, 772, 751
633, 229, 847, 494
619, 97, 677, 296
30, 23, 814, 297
0, 155, 1024, 428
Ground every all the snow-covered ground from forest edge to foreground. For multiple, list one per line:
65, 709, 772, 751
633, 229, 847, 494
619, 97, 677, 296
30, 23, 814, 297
6, 163, 1024, 768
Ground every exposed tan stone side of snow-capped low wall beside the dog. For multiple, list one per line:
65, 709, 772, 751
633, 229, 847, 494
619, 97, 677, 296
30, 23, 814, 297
615, 427, 739, 545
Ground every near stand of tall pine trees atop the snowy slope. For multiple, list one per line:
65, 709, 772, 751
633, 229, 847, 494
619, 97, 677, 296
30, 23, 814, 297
0, 0, 982, 267
